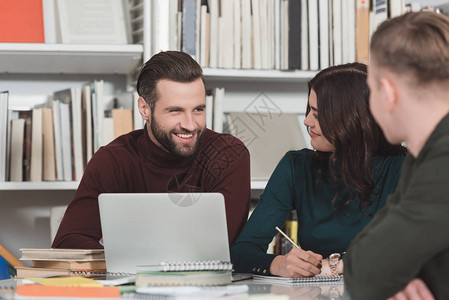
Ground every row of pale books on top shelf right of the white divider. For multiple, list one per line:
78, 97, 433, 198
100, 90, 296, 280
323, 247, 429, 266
151, 0, 438, 70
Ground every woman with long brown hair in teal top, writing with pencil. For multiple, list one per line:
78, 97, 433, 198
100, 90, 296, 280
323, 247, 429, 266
231, 63, 406, 277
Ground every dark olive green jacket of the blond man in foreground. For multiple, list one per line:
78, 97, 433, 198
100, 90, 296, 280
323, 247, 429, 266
344, 115, 449, 300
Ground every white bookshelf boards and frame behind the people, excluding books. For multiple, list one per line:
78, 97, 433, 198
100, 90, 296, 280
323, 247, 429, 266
0, 0, 447, 262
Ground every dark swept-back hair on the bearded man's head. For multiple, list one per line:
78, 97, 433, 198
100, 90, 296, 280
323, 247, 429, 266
137, 51, 204, 111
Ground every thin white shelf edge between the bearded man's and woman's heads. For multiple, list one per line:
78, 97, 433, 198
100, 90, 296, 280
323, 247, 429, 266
203, 68, 317, 82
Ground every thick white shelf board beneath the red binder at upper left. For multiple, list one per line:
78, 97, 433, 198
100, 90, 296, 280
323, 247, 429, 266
0, 43, 143, 74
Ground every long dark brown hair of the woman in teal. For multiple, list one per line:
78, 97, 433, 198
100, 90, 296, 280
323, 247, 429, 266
306, 63, 406, 215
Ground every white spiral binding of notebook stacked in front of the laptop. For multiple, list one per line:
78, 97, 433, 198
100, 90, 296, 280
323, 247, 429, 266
160, 260, 232, 272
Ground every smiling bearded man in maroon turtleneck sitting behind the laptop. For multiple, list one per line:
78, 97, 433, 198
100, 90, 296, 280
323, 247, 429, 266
52, 51, 251, 249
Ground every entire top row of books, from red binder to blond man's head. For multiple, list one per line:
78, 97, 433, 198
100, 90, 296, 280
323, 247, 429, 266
0, 0, 440, 70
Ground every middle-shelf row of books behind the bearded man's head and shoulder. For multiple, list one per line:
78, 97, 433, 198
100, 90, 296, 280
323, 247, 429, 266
0, 85, 224, 182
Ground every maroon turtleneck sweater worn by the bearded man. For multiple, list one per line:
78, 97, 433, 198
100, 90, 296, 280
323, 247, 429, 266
52, 129, 251, 249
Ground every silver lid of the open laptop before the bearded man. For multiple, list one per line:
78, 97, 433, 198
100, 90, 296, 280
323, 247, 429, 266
98, 193, 230, 273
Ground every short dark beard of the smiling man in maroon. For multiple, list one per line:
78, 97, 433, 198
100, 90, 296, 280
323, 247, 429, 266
150, 116, 203, 158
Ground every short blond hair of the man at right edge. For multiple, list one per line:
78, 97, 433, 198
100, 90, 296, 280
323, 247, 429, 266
370, 12, 449, 84
